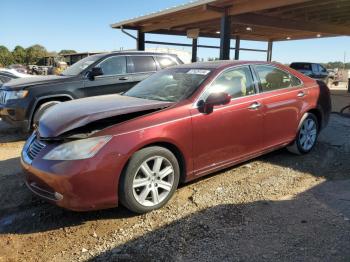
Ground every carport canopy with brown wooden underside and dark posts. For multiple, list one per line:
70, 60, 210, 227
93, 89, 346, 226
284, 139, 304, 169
111, 0, 350, 60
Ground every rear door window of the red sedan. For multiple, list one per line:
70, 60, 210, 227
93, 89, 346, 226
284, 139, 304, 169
255, 65, 301, 92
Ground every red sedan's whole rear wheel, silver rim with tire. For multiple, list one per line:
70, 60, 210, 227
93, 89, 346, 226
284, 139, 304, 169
287, 113, 319, 155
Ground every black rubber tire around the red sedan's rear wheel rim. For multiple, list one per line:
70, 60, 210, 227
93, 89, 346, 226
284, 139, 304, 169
287, 113, 320, 155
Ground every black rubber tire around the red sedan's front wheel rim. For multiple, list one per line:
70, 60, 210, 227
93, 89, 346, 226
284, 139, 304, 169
119, 146, 180, 214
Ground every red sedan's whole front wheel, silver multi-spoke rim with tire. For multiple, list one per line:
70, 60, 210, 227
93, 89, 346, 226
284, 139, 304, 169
119, 146, 180, 214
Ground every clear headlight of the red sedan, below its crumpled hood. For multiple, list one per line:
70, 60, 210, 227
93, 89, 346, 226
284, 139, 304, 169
43, 136, 112, 160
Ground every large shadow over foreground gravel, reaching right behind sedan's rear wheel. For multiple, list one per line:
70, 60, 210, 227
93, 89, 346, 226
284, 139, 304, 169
90, 124, 350, 261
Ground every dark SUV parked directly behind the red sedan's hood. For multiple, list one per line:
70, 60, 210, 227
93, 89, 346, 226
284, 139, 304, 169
0, 52, 182, 131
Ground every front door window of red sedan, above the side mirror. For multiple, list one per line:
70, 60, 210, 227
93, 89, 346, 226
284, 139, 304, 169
209, 67, 256, 98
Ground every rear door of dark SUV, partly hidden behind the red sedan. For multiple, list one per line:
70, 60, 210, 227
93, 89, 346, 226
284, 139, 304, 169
127, 55, 157, 85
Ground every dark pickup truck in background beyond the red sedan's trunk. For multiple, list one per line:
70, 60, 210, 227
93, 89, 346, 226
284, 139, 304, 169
290, 62, 330, 84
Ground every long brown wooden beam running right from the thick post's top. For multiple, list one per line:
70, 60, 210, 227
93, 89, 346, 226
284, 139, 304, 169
231, 14, 350, 35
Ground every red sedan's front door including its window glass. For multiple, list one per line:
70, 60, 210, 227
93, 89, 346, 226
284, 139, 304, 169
191, 66, 263, 175
